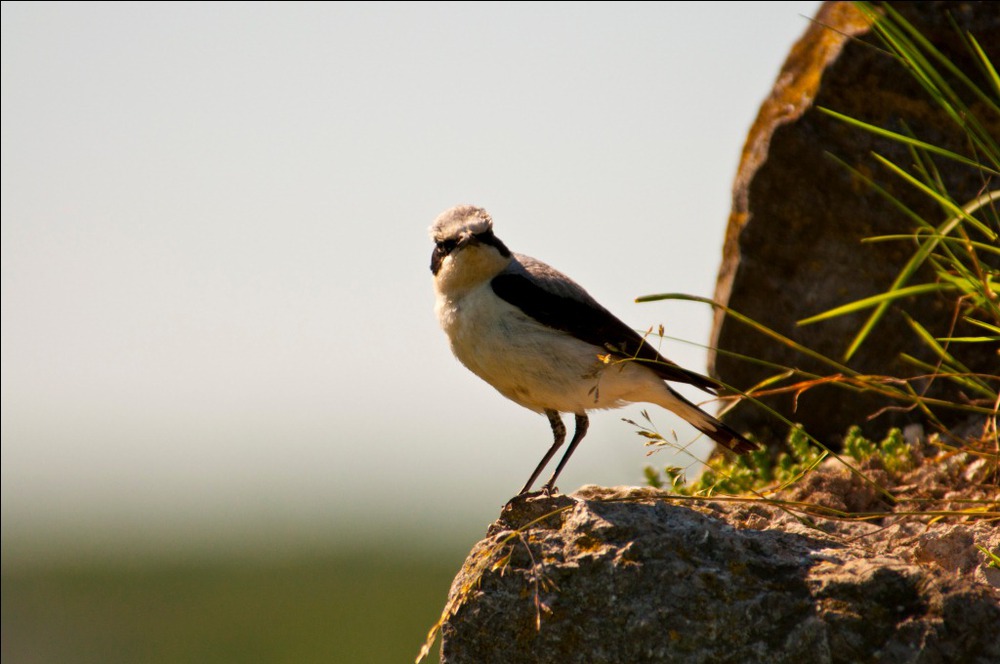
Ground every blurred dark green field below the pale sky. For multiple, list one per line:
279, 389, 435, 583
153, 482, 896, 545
2, 549, 465, 664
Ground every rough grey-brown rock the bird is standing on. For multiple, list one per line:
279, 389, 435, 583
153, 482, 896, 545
441, 487, 1000, 664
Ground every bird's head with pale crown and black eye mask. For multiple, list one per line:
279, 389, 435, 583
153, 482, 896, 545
430, 205, 512, 291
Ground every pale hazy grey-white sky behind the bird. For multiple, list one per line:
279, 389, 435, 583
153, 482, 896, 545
0, 2, 819, 556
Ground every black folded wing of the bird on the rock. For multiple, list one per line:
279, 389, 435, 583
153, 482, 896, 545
490, 254, 722, 394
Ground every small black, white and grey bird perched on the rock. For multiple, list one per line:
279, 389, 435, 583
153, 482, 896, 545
430, 205, 758, 496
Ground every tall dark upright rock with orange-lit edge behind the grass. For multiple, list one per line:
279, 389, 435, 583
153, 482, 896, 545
709, 2, 1000, 447
